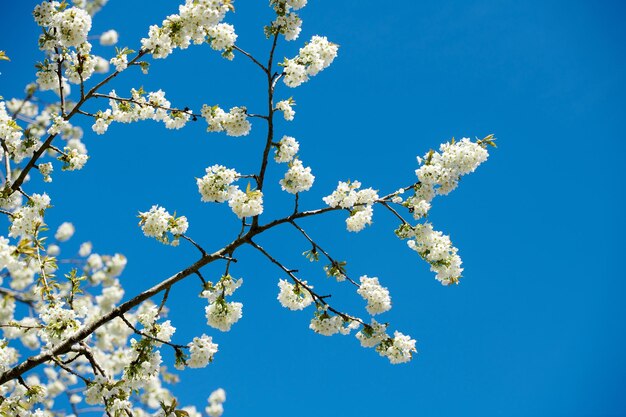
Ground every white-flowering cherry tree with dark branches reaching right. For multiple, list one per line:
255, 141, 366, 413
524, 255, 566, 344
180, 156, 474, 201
0, 0, 495, 417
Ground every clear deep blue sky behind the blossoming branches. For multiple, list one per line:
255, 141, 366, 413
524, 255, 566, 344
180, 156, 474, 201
0, 0, 626, 417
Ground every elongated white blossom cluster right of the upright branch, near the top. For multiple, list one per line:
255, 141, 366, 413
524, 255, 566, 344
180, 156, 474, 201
282, 35, 339, 87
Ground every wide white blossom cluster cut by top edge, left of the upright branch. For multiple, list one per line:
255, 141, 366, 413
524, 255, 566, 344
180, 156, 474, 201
141, 0, 237, 59
